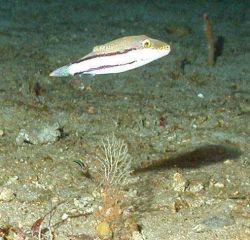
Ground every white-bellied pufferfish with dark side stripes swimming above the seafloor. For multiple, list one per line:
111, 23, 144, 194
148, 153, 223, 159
50, 35, 170, 77
